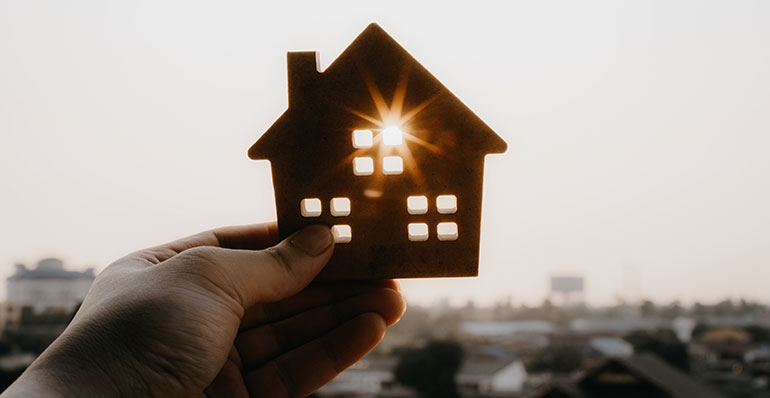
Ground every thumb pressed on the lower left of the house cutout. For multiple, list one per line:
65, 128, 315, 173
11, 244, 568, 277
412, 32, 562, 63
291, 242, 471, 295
171, 225, 334, 308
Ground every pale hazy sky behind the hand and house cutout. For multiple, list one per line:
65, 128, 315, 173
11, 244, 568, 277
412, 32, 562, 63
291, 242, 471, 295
0, 0, 770, 305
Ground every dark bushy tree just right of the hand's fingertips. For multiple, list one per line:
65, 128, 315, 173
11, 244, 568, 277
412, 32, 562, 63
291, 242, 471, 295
393, 340, 464, 398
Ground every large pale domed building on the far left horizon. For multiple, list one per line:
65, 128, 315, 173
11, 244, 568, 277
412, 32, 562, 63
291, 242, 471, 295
7, 258, 94, 312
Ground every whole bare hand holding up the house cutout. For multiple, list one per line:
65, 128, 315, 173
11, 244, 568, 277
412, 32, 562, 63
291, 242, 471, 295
2, 224, 405, 398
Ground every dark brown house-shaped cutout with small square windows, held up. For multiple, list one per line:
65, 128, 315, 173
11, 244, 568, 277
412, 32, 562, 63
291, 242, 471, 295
249, 24, 507, 280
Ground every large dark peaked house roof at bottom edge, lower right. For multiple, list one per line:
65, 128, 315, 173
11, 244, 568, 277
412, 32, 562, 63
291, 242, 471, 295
528, 353, 721, 398
